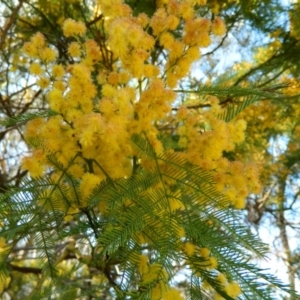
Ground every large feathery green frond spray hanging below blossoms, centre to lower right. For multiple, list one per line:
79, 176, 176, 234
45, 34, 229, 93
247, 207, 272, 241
81, 136, 292, 299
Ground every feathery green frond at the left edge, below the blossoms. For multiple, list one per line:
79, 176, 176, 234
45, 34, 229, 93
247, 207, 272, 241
0, 177, 69, 276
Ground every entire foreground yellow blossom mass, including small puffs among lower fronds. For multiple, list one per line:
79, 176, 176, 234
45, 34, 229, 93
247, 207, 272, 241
22, 0, 260, 299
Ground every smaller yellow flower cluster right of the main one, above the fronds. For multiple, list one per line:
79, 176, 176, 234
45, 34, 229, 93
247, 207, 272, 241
177, 98, 260, 209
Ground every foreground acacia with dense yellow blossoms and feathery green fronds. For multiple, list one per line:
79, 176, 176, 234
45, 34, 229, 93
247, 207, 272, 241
0, 0, 296, 299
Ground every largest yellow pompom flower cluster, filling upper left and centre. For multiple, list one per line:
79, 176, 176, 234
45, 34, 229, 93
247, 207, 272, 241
23, 0, 227, 192
